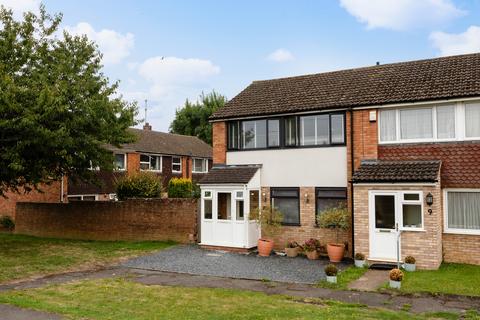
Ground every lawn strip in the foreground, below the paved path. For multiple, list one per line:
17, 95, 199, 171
0, 279, 468, 320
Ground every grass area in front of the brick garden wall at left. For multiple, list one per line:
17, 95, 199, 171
0, 233, 174, 283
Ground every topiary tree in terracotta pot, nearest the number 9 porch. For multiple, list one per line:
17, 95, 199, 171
317, 206, 350, 262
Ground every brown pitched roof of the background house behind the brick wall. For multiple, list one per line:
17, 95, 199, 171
114, 128, 212, 158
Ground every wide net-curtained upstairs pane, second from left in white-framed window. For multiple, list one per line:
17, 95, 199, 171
400, 108, 433, 139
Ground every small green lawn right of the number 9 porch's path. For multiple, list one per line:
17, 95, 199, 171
401, 263, 480, 296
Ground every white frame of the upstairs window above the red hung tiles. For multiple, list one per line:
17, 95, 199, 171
377, 102, 462, 145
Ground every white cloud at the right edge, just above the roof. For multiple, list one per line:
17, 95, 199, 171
430, 26, 480, 56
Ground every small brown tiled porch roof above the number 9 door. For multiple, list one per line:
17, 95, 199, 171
352, 160, 441, 183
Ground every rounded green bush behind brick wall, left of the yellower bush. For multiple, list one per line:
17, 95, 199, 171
116, 171, 162, 200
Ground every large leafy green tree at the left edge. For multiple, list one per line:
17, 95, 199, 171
0, 6, 137, 195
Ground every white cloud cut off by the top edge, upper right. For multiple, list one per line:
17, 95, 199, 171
340, 0, 466, 30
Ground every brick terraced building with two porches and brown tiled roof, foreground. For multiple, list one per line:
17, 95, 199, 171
200, 54, 480, 269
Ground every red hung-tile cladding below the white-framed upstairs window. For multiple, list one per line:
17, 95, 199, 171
378, 142, 480, 188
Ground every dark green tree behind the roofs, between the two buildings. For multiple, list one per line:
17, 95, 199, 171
170, 91, 227, 145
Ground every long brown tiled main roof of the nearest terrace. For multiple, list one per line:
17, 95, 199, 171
211, 53, 480, 120
